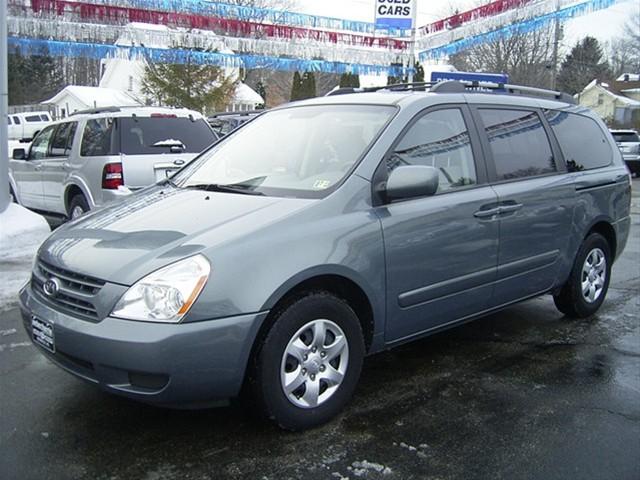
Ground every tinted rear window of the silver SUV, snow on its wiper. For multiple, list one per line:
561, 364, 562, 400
118, 116, 217, 155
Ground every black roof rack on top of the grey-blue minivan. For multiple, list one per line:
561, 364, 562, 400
327, 80, 576, 104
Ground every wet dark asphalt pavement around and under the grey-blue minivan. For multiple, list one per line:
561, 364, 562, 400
0, 180, 640, 480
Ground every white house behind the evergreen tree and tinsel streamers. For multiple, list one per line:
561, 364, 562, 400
100, 23, 264, 113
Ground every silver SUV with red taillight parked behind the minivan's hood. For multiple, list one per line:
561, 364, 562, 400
9, 107, 217, 218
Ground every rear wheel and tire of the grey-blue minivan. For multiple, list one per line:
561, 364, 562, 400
553, 233, 613, 318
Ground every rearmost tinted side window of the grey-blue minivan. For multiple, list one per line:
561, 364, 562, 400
544, 110, 612, 172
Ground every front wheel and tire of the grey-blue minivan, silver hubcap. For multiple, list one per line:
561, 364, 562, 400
249, 292, 365, 430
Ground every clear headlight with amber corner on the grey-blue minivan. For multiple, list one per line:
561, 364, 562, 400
111, 255, 211, 323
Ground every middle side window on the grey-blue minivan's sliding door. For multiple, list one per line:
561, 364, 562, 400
479, 109, 557, 180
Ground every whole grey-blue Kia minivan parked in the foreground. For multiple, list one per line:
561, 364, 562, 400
20, 81, 631, 430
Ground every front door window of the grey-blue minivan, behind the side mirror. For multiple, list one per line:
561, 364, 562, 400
387, 108, 477, 193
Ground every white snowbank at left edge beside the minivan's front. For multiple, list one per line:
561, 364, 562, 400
0, 203, 51, 311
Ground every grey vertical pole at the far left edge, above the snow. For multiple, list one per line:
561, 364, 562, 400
0, 0, 9, 213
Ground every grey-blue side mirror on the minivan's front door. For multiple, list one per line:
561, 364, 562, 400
385, 165, 438, 201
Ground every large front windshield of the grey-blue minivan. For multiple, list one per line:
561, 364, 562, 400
173, 105, 395, 198
